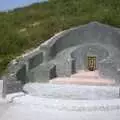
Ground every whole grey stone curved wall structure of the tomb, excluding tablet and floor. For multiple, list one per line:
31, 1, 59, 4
3, 22, 120, 96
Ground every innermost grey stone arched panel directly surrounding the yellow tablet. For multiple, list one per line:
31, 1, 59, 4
71, 44, 109, 70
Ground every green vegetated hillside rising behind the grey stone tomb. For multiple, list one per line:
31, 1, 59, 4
0, 0, 120, 73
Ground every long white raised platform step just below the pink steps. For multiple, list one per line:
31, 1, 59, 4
23, 83, 119, 100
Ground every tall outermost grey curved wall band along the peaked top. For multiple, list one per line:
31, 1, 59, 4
49, 22, 120, 57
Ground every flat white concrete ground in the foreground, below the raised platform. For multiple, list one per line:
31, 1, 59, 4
0, 96, 120, 120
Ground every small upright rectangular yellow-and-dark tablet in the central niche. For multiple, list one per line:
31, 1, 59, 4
87, 56, 96, 71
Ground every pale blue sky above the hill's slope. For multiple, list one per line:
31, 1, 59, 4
0, 0, 47, 11
